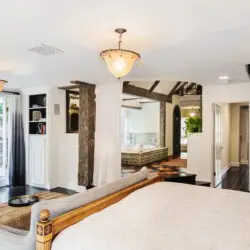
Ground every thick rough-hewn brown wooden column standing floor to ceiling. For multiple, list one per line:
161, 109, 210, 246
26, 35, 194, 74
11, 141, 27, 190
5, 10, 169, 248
78, 83, 96, 187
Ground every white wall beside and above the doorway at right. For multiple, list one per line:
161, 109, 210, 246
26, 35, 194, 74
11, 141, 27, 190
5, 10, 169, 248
188, 83, 250, 186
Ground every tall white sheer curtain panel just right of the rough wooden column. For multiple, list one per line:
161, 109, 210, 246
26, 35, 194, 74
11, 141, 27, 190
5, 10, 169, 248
94, 81, 122, 186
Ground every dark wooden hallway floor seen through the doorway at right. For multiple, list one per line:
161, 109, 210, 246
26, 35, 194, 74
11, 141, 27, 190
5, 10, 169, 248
218, 165, 249, 192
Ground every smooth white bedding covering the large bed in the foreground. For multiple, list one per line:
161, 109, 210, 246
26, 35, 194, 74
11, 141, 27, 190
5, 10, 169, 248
52, 182, 250, 250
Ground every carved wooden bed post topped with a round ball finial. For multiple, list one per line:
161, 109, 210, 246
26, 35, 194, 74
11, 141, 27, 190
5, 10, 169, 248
36, 209, 52, 250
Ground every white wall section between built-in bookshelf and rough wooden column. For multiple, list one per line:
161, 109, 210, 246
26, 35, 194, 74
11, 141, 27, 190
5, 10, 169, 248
50, 88, 78, 190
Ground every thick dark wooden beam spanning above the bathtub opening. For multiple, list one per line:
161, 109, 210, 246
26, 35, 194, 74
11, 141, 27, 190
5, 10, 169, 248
123, 85, 170, 102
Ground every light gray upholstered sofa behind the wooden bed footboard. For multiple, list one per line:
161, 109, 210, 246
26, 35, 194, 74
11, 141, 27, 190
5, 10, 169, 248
0, 168, 148, 250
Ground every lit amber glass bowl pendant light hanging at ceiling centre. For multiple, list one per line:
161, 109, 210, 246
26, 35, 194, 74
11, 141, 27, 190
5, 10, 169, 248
100, 28, 141, 78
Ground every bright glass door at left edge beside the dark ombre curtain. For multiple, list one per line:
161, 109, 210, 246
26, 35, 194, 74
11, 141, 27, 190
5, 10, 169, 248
0, 96, 8, 187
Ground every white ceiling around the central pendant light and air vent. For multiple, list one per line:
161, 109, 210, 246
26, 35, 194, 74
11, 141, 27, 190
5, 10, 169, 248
0, 0, 250, 88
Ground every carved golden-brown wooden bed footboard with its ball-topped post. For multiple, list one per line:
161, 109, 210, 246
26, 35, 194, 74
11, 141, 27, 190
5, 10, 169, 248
36, 176, 162, 250
